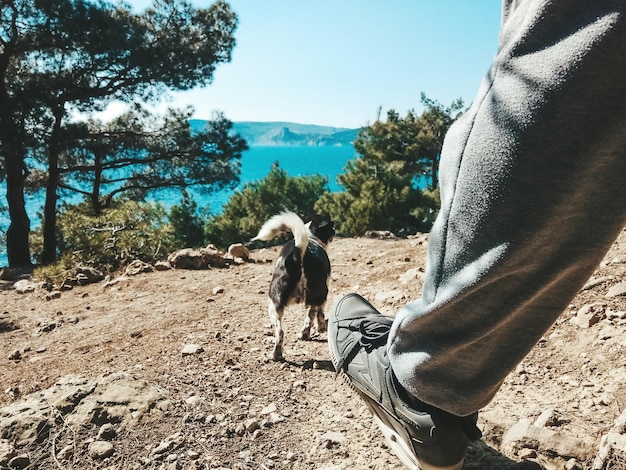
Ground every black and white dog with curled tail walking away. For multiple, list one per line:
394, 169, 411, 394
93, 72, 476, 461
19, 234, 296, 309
252, 212, 335, 361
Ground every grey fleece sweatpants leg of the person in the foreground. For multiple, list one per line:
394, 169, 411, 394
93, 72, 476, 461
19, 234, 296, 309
388, 0, 626, 416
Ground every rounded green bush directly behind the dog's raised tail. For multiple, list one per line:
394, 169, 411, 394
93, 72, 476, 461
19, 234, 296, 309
205, 162, 328, 247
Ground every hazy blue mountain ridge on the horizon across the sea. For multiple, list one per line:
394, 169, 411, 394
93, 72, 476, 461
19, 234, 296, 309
189, 119, 359, 147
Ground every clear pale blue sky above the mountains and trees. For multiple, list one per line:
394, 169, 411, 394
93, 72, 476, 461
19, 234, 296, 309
122, 0, 501, 128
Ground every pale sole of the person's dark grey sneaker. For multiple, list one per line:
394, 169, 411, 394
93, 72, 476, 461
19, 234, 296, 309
328, 335, 463, 470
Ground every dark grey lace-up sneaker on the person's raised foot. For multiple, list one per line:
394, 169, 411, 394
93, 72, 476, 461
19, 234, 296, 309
328, 294, 481, 470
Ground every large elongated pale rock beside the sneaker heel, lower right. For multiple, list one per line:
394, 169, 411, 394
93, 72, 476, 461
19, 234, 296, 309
501, 419, 594, 462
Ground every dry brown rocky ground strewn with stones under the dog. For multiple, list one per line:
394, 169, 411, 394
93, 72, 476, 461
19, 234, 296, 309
0, 234, 626, 470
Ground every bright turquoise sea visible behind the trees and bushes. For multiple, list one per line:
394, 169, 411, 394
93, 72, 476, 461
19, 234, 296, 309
0, 145, 357, 266
